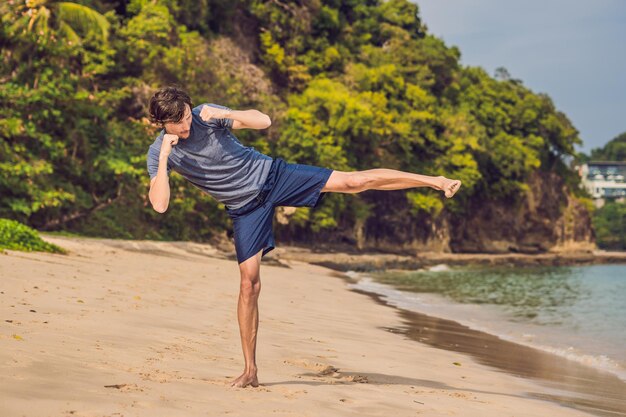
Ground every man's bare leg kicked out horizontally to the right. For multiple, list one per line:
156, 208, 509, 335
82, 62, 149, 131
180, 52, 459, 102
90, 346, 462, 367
322, 168, 461, 198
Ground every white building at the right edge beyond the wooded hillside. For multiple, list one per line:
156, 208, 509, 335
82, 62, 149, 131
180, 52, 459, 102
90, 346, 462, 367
578, 162, 626, 207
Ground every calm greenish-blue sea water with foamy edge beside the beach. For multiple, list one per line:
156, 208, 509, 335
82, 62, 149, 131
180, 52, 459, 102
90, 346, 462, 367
352, 265, 626, 381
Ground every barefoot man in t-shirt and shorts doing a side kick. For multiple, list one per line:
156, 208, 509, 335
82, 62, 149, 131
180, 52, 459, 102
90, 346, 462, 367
147, 87, 461, 387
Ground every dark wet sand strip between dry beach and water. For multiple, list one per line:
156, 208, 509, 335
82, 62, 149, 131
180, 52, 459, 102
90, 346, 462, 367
338, 273, 626, 416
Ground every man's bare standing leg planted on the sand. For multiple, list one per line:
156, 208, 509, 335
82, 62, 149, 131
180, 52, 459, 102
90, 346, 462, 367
231, 247, 263, 388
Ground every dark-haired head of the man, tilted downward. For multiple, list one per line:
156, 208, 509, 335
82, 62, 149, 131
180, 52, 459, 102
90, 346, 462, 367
149, 87, 193, 139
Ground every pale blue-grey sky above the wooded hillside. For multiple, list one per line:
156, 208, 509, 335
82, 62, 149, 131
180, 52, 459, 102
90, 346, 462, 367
417, 0, 626, 153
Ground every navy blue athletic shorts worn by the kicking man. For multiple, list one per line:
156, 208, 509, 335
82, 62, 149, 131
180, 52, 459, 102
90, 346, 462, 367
226, 158, 333, 263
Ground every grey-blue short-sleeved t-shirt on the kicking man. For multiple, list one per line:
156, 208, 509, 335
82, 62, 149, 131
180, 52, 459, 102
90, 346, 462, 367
147, 103, 272, 209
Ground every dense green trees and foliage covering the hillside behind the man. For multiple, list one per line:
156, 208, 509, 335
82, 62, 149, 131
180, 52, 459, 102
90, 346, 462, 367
0, 0, 580, 247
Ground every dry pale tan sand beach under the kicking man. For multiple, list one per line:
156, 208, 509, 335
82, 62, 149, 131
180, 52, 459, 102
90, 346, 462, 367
0, 236, 616, 417
